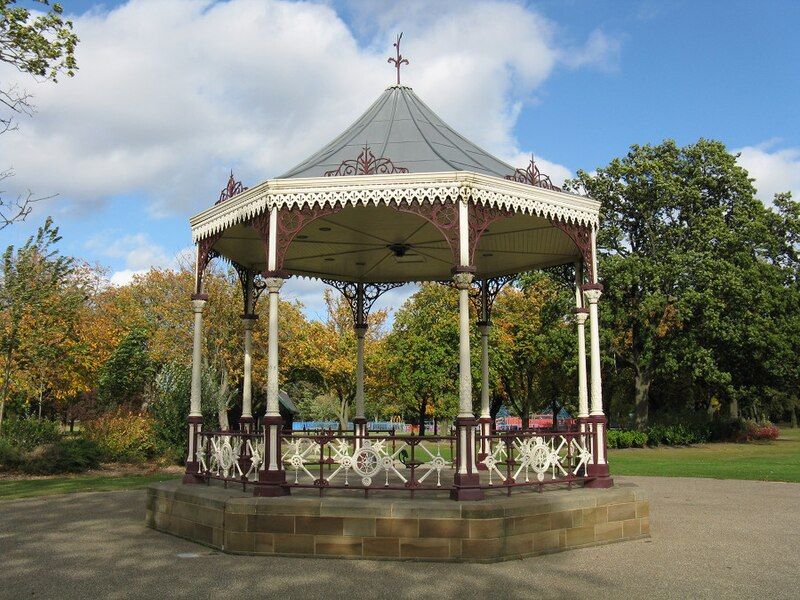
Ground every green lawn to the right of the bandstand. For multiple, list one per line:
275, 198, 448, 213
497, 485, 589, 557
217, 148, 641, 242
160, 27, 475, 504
609, 429, 800, 483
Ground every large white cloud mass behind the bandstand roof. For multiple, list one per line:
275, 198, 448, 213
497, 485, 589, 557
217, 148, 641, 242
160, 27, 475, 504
0, 0, 616, 216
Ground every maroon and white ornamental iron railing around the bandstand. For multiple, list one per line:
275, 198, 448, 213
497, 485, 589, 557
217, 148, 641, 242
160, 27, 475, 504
197, 429, 592, 497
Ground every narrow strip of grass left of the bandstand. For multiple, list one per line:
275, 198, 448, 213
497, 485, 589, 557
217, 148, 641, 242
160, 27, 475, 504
0, 473, 176, 500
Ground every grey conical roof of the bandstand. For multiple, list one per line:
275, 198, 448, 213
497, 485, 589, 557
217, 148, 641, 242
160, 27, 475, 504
278, 86, 514, 179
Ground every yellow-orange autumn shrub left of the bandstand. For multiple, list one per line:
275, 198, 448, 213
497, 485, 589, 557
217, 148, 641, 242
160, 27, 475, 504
83, 408, 156, 462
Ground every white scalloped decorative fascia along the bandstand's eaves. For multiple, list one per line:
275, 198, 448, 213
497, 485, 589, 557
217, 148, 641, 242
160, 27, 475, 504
189, 171, 600, 242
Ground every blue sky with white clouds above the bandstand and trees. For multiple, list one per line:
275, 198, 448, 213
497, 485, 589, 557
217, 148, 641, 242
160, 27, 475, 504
0, 0, 800, 315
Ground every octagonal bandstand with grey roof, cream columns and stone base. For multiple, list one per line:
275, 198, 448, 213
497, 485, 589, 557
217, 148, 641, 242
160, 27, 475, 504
148, 38, 648, 560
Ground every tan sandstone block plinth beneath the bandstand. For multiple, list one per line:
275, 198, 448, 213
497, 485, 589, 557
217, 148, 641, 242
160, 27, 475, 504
147, 481, 650, 562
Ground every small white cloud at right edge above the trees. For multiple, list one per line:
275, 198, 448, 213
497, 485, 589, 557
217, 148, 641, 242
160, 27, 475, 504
734, 140, 800, 203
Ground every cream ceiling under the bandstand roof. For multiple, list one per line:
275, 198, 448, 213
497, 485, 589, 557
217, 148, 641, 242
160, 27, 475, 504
209, 206, 580, 282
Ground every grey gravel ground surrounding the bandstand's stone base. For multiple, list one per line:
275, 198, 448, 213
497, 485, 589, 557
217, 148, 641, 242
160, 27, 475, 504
0, 477, 800, 600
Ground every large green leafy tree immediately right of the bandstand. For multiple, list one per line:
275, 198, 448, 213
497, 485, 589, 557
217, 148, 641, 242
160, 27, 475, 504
568, 139, 786, 426
